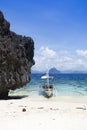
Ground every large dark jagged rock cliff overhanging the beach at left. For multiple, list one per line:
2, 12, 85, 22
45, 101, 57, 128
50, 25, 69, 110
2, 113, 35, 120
0, 11, 34, 98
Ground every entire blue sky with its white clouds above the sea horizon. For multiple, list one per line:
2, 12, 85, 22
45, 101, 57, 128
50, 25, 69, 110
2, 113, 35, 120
0, 0, 87, 71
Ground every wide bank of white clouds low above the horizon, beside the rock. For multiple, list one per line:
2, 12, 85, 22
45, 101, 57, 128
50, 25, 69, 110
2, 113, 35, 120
34, 47, 87, 71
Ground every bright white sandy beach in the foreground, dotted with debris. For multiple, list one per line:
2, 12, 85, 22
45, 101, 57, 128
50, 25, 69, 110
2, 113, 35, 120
0, 96, 87, 130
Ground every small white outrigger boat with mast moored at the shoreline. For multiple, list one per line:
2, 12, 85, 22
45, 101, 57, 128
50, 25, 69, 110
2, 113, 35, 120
41, 71, 54, 98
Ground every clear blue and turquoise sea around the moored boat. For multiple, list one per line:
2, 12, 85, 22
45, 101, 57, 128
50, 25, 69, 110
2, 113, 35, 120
11, 74, 87, 96
